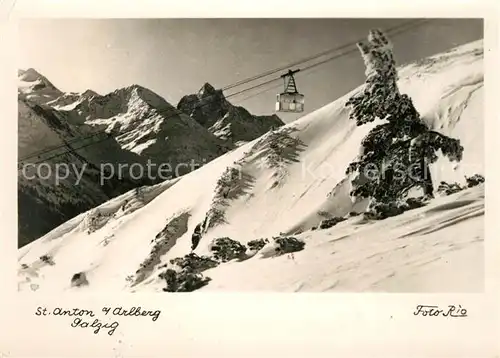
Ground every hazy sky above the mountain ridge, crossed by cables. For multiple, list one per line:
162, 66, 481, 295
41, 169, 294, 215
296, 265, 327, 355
18, 18, 483, 122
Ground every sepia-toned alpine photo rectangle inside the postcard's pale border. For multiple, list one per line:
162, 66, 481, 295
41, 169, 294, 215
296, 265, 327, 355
16, 17, 489, 294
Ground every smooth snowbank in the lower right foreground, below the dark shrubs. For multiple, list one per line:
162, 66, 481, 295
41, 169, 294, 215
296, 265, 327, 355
201, 186, 484, 292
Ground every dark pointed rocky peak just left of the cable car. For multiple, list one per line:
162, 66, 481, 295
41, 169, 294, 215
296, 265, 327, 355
177, 83, 285, 144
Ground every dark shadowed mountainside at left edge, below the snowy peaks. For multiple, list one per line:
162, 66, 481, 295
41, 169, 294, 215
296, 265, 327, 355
18, 93, 146, 246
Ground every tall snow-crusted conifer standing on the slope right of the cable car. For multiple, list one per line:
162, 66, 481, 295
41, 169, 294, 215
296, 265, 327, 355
346, 30, 463, 202
